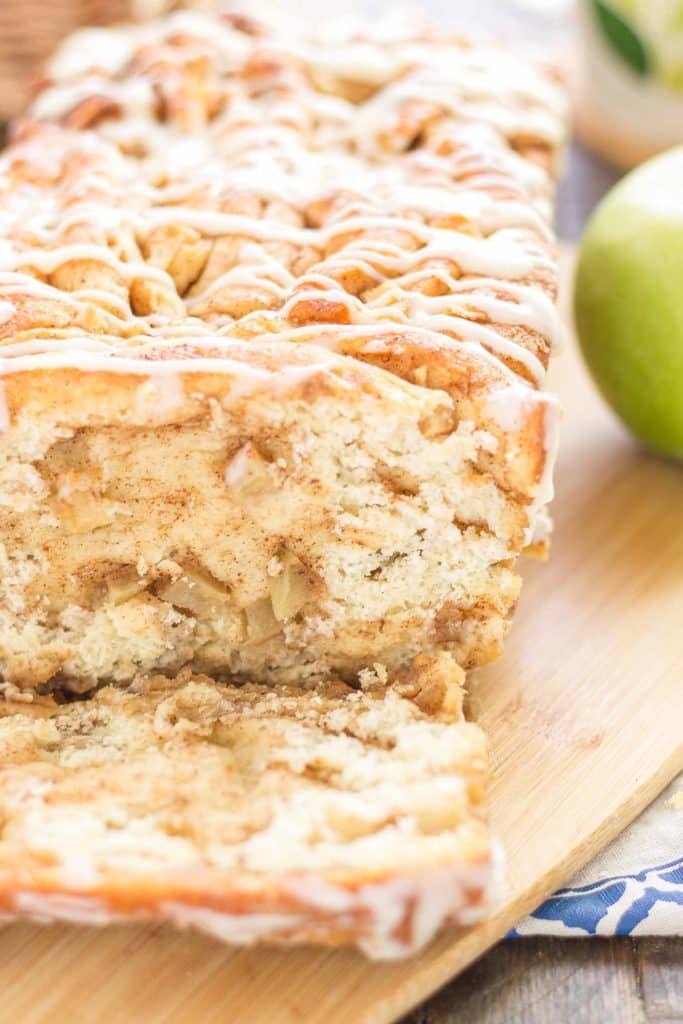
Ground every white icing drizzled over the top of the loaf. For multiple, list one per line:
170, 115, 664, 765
0, 12, 564, 540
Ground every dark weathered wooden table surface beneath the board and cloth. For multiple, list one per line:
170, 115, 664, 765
403, 144, 683, 1024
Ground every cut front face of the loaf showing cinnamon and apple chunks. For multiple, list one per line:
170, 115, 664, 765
0, 392, 518, 692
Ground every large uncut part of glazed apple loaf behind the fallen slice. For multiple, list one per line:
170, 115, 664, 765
0, 6, 564, 693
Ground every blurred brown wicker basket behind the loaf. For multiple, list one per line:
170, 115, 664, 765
0, 0, 140, 120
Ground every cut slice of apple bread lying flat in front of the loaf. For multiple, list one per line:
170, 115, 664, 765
0, 655, 496, 958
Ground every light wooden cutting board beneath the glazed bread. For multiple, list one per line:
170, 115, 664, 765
0, 249, 683, 1024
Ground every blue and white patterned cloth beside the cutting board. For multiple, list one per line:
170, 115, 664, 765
511, 776, 683, 937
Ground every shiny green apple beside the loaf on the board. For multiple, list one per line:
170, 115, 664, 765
574, 147, 683, 459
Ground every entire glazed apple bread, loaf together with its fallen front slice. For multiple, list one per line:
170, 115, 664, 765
0, 6, 564, 953
